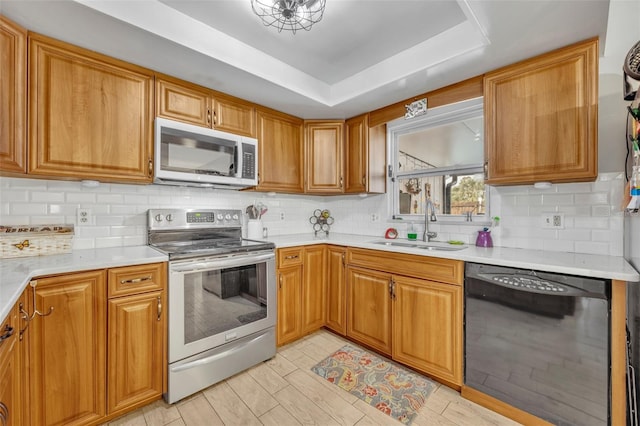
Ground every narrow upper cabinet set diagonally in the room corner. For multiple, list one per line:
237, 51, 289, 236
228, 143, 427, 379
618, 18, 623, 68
305, 120, 344, 194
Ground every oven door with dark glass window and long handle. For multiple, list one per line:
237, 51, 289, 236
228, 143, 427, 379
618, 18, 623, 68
169, 251, 276, 363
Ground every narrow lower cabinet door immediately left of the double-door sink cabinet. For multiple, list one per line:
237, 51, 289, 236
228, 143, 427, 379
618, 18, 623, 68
326, 246, 347, 336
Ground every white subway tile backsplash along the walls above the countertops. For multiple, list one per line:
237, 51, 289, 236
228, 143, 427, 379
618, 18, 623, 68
0, 173, 624, 256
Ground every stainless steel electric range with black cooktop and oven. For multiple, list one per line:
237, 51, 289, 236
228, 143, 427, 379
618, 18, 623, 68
148, 209, 276, 403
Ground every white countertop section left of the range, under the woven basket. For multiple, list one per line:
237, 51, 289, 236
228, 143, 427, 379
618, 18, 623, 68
0, 246, 168, 320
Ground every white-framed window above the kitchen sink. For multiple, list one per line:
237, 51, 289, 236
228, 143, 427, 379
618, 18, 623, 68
389, 98, 488, 220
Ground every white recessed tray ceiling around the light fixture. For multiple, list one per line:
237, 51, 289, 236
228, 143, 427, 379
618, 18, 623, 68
0, 0, 608, 118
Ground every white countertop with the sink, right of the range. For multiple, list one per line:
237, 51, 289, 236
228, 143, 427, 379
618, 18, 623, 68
260, 234, 640, 282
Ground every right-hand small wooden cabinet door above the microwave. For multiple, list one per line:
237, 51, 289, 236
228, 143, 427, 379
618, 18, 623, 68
213, 94, 256, 138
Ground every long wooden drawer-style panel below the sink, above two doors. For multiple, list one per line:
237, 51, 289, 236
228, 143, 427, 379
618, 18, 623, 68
347, 248, 464, 285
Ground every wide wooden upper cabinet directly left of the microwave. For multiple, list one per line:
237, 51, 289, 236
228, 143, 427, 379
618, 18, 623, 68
28, 33, 153, 183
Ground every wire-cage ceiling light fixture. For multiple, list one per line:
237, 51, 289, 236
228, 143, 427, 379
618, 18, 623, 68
251, 0, 327, 34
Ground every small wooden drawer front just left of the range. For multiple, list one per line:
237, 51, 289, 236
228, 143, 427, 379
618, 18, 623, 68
109, 263, 166, 298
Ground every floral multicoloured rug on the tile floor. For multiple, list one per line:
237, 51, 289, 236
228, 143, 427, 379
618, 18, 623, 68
311, 345, 435, 425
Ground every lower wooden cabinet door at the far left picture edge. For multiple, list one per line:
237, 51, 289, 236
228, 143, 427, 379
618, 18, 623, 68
0, 298, 24, 426
